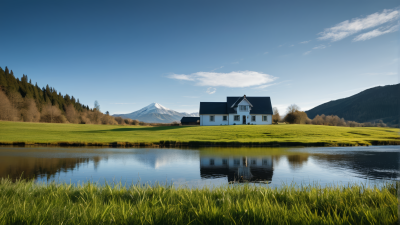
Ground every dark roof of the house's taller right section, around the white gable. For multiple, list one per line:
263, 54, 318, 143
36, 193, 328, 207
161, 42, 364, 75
226, 96, 273, 114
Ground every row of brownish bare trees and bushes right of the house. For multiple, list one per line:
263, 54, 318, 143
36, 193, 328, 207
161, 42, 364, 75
272, 104, 387, 127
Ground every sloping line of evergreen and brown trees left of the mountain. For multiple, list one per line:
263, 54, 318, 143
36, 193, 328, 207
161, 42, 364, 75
0, 67, 166, 125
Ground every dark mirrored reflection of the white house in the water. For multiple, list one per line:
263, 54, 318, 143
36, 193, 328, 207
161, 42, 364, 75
200, 156, 273, 183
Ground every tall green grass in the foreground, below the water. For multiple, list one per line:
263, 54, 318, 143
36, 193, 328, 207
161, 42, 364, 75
0, 179, 398, 224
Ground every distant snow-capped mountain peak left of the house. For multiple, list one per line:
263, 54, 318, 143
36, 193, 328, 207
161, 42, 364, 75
113, 103, 199, 123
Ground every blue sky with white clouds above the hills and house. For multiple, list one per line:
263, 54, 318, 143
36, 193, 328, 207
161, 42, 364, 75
0, 0, 400, 114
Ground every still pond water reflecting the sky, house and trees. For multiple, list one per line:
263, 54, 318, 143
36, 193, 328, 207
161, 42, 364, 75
0, 146, 400, 187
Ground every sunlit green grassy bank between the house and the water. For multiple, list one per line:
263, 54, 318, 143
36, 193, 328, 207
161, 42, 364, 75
0, 121, 400, 146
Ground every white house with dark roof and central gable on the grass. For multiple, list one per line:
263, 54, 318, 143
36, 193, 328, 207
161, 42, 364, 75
199, 95, 272, 126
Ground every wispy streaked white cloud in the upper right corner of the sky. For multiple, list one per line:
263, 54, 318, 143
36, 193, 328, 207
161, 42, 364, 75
318, 9, 400, 41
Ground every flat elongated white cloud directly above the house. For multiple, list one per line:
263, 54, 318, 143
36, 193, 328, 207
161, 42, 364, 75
168, 70, 277, 88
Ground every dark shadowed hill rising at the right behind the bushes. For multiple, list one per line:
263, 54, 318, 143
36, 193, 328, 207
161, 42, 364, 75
306, 84, 400, 125
